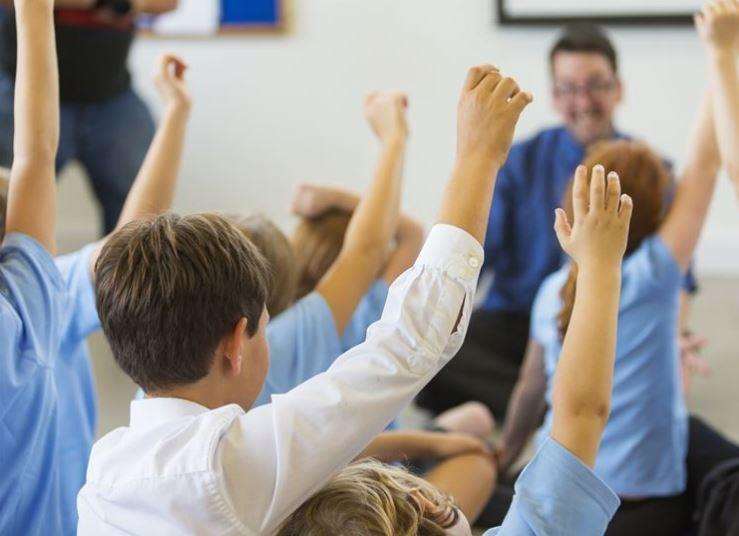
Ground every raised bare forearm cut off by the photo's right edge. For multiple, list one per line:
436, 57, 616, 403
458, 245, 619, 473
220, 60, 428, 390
709, 49, 739, 188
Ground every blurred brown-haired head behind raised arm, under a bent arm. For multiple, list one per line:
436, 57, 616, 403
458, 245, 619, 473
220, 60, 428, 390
292, 210, 352, 298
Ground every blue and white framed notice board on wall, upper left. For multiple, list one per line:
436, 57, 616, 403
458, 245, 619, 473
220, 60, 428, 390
141, 0, 283, 37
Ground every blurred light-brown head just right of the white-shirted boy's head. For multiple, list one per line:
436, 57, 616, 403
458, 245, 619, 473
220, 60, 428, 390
228, 214, 298, 317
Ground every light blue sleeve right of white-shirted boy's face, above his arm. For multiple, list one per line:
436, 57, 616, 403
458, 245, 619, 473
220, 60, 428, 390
254, 292, 342, 407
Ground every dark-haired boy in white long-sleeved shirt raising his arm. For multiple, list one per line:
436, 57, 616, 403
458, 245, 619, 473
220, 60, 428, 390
78, 62, 531, 535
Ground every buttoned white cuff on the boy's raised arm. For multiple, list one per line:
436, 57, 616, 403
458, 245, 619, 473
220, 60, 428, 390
416, 223, 485, 286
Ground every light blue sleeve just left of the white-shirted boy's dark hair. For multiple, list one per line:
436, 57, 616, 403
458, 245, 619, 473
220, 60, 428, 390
54, 243, 100, 343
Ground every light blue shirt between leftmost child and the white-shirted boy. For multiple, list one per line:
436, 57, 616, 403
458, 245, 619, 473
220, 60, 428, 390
54, 244, 100, 534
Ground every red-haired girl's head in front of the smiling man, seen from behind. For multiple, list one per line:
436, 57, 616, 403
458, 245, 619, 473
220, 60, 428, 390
559, 140, 670, 336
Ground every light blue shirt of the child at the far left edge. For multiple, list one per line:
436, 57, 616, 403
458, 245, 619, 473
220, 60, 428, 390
0, 233, 67, 535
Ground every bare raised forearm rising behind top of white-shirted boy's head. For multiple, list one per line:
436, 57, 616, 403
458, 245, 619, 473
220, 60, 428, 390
117, 104, 190, 232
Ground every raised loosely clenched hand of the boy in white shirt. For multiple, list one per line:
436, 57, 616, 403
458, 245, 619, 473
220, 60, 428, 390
457, 65, 533, 167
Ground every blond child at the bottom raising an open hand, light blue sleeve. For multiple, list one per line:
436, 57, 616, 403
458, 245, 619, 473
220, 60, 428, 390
277, 166, 632, 536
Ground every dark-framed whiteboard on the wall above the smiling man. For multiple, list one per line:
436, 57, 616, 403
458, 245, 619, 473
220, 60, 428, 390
493, 0, 702, 25
